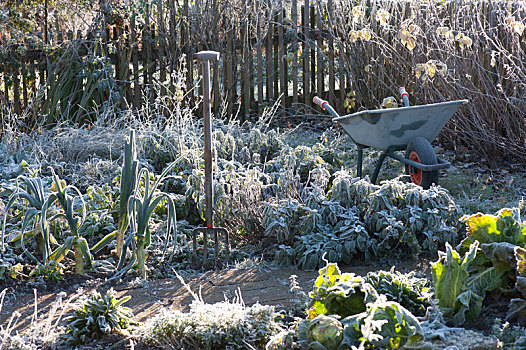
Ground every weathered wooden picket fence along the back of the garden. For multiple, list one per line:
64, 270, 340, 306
0, 0, 524, 126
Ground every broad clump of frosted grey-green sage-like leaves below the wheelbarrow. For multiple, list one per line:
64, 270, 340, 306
268, 172, 459, 269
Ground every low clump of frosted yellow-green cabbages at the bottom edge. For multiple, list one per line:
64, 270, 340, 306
297, 261, 428, 350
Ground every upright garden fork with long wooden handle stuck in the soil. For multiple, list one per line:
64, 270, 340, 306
192, 51, 229, 268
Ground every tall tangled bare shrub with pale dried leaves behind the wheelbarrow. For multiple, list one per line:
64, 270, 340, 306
333, 0, 526, 165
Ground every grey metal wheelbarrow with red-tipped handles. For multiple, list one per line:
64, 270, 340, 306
314, 88, 468, 189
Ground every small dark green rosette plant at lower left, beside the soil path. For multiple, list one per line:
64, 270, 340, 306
64, 289, 134, 343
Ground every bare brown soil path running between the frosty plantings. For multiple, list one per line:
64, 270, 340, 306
0, 259, 429, 332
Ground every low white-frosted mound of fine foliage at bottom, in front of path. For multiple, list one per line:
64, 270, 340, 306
138, 276, 284, 350
